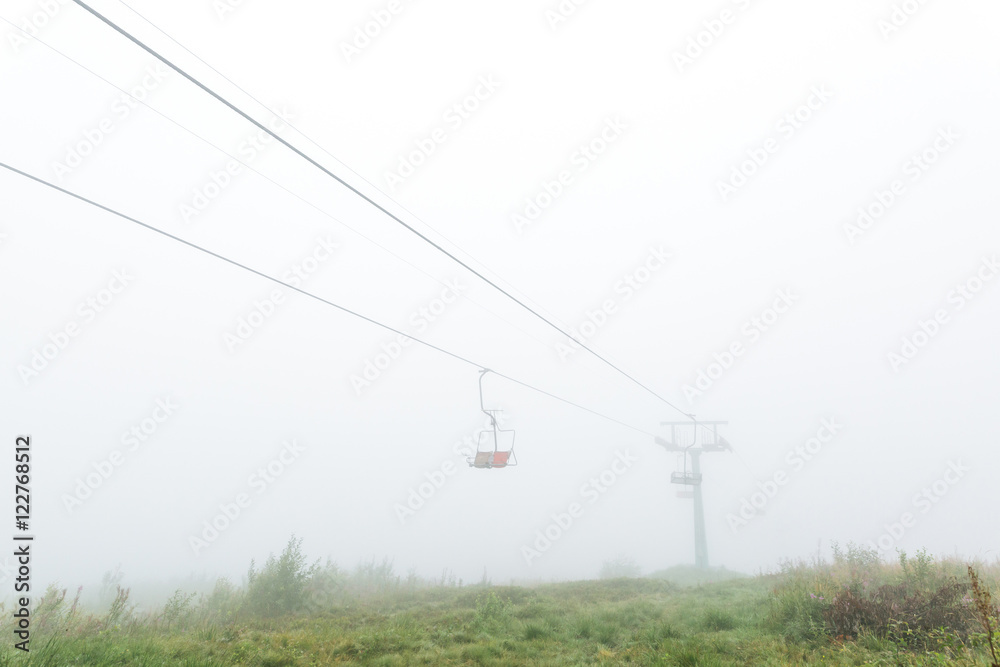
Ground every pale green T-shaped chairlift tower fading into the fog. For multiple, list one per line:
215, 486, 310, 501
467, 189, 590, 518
655, 415, 732, 568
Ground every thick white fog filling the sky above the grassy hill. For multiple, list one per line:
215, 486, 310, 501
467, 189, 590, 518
0, 0, 1000, 589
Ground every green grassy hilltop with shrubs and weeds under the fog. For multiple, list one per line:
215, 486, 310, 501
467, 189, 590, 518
0, 540, 1000, 667
